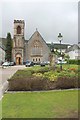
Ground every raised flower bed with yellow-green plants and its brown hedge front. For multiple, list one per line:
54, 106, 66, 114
9, 64, 80, 90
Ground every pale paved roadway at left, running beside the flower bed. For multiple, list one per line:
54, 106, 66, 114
0, 65, 25, 99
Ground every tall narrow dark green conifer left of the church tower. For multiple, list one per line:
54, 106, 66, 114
6, 33, 12, 61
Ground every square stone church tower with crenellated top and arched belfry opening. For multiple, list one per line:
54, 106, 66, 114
12, 20, 25, 65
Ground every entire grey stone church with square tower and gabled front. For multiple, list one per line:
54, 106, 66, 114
12, 20, 50, 65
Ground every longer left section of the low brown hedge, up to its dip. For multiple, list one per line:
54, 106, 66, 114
9, 77, 54, 91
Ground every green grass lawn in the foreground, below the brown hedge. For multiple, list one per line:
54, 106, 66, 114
2, 90, 78, 118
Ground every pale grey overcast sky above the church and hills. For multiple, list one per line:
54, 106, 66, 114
0, 0, 78, 44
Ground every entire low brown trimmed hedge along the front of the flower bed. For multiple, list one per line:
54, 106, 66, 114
8, 77, 80, 91
